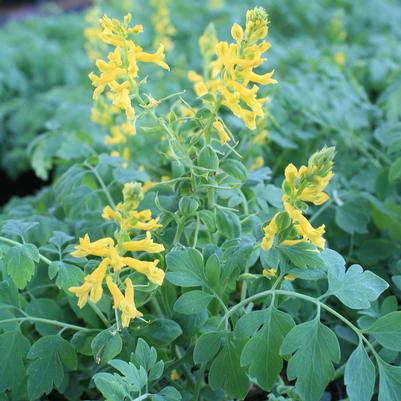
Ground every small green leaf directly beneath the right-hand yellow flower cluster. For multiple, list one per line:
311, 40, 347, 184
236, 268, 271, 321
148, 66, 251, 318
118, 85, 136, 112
278, 242, 324, 269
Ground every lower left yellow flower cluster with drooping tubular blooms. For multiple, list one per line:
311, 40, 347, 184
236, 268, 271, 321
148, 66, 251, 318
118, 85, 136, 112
69, 183, 164, 327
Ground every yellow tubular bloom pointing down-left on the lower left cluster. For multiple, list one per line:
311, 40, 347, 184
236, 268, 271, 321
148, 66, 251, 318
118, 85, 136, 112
68, 258, 110, 309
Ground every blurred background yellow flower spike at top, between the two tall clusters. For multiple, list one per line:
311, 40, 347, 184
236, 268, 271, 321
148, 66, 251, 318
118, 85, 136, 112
150, 0, 176, 50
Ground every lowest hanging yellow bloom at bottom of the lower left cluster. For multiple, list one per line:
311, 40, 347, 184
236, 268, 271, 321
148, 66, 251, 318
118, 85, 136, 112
106, 276, 143, 327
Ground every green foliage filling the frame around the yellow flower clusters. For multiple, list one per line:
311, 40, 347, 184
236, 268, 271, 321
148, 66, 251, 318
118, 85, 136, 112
0, 0, 401, 401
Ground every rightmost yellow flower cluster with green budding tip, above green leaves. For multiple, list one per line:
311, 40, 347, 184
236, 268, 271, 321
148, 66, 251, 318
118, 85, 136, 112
261, 147, 335, 250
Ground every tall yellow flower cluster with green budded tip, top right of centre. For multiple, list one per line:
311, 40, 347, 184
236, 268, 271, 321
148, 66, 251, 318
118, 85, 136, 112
188, 7, 277, 144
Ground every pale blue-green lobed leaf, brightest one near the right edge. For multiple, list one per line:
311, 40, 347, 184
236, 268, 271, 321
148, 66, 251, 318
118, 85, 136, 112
328, 264, 388, 309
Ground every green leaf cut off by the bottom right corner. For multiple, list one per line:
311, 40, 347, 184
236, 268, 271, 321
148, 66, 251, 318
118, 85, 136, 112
379, 359, 401, 401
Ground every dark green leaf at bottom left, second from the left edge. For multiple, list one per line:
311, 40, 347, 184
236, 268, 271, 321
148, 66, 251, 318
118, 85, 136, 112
27, 335, 77, 400
